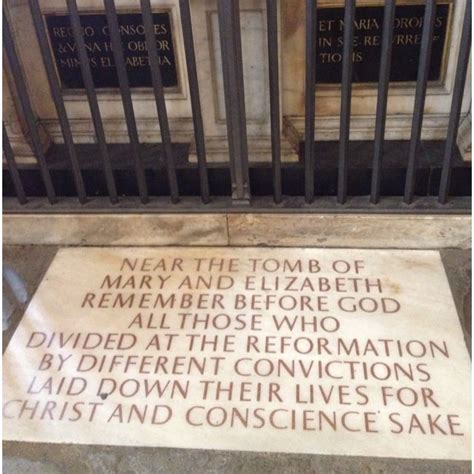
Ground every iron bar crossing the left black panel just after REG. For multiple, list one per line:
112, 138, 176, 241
66, 0, 118, 203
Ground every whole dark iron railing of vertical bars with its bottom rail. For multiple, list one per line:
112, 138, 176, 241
3, 0, 471, 212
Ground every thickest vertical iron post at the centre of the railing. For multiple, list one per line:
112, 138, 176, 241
217, 0, 250, 202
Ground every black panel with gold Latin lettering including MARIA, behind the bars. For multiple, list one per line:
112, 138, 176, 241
316, 4, 450, 83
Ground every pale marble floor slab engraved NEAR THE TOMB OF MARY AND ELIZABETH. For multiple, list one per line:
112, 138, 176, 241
3, 248, 471, 460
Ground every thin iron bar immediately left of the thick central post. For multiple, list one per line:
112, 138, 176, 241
179, 0, 210, 203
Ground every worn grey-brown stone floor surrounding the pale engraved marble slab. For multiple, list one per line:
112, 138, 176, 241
3, 246, 471, 474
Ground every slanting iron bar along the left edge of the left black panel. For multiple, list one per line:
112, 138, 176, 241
29, 0, 87, 204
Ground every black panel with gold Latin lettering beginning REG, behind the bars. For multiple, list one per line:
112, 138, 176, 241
46, 12, 178, 89
